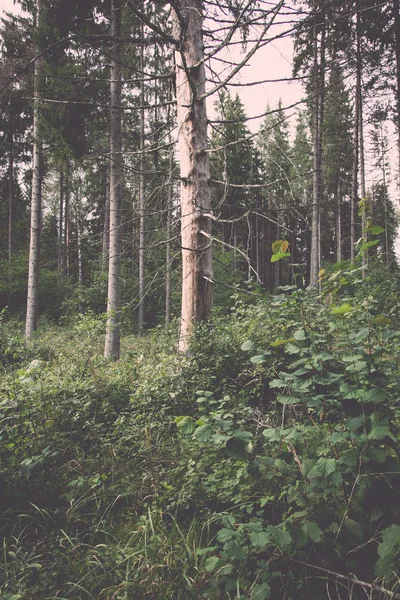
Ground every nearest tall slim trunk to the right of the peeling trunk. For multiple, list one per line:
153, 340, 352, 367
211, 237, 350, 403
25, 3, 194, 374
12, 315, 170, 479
310, 25, 321, 287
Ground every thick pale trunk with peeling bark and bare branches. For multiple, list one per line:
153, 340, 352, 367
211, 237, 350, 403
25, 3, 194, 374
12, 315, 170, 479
175, 0, 213, 352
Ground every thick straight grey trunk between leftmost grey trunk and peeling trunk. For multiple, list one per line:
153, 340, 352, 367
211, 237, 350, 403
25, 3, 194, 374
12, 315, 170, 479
104, 0, 122, 358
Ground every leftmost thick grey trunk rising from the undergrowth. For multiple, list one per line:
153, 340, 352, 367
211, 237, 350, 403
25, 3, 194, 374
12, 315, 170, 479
25, 0, 44, 339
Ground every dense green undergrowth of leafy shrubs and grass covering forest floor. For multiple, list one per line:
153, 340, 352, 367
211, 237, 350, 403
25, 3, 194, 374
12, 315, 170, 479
0, 265, 400, 600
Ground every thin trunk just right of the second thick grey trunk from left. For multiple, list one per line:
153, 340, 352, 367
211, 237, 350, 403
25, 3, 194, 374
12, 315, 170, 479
138, 34, 145, 332
